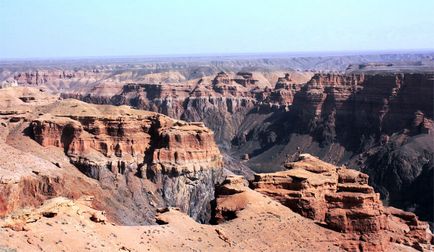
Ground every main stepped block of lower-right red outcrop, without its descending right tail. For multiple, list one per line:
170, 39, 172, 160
252, 155, 384, 233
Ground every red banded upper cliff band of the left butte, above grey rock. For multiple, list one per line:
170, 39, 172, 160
30, 110, 221, 175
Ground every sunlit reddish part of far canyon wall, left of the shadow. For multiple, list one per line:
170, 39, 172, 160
58, 71, 311, 150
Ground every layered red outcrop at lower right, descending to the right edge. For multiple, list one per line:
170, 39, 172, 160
251, 154, 432, 250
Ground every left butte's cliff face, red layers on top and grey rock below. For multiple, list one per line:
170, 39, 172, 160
26, 101, 222, 222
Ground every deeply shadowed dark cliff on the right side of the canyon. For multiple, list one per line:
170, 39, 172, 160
294, 74, 434, 222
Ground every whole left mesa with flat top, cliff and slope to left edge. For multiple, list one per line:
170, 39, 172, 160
0, 89, 222, 224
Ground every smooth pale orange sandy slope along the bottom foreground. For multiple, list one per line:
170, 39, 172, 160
0, 171, 429, 251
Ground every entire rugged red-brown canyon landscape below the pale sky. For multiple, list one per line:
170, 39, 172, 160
0, 53, 434, 251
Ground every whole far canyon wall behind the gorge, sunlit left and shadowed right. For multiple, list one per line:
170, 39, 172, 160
6, 71, 434, 226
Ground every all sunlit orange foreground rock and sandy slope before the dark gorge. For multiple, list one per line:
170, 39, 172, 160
0, 85, 432, 251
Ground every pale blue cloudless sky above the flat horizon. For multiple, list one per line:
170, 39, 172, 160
0, 0, 434, 59
